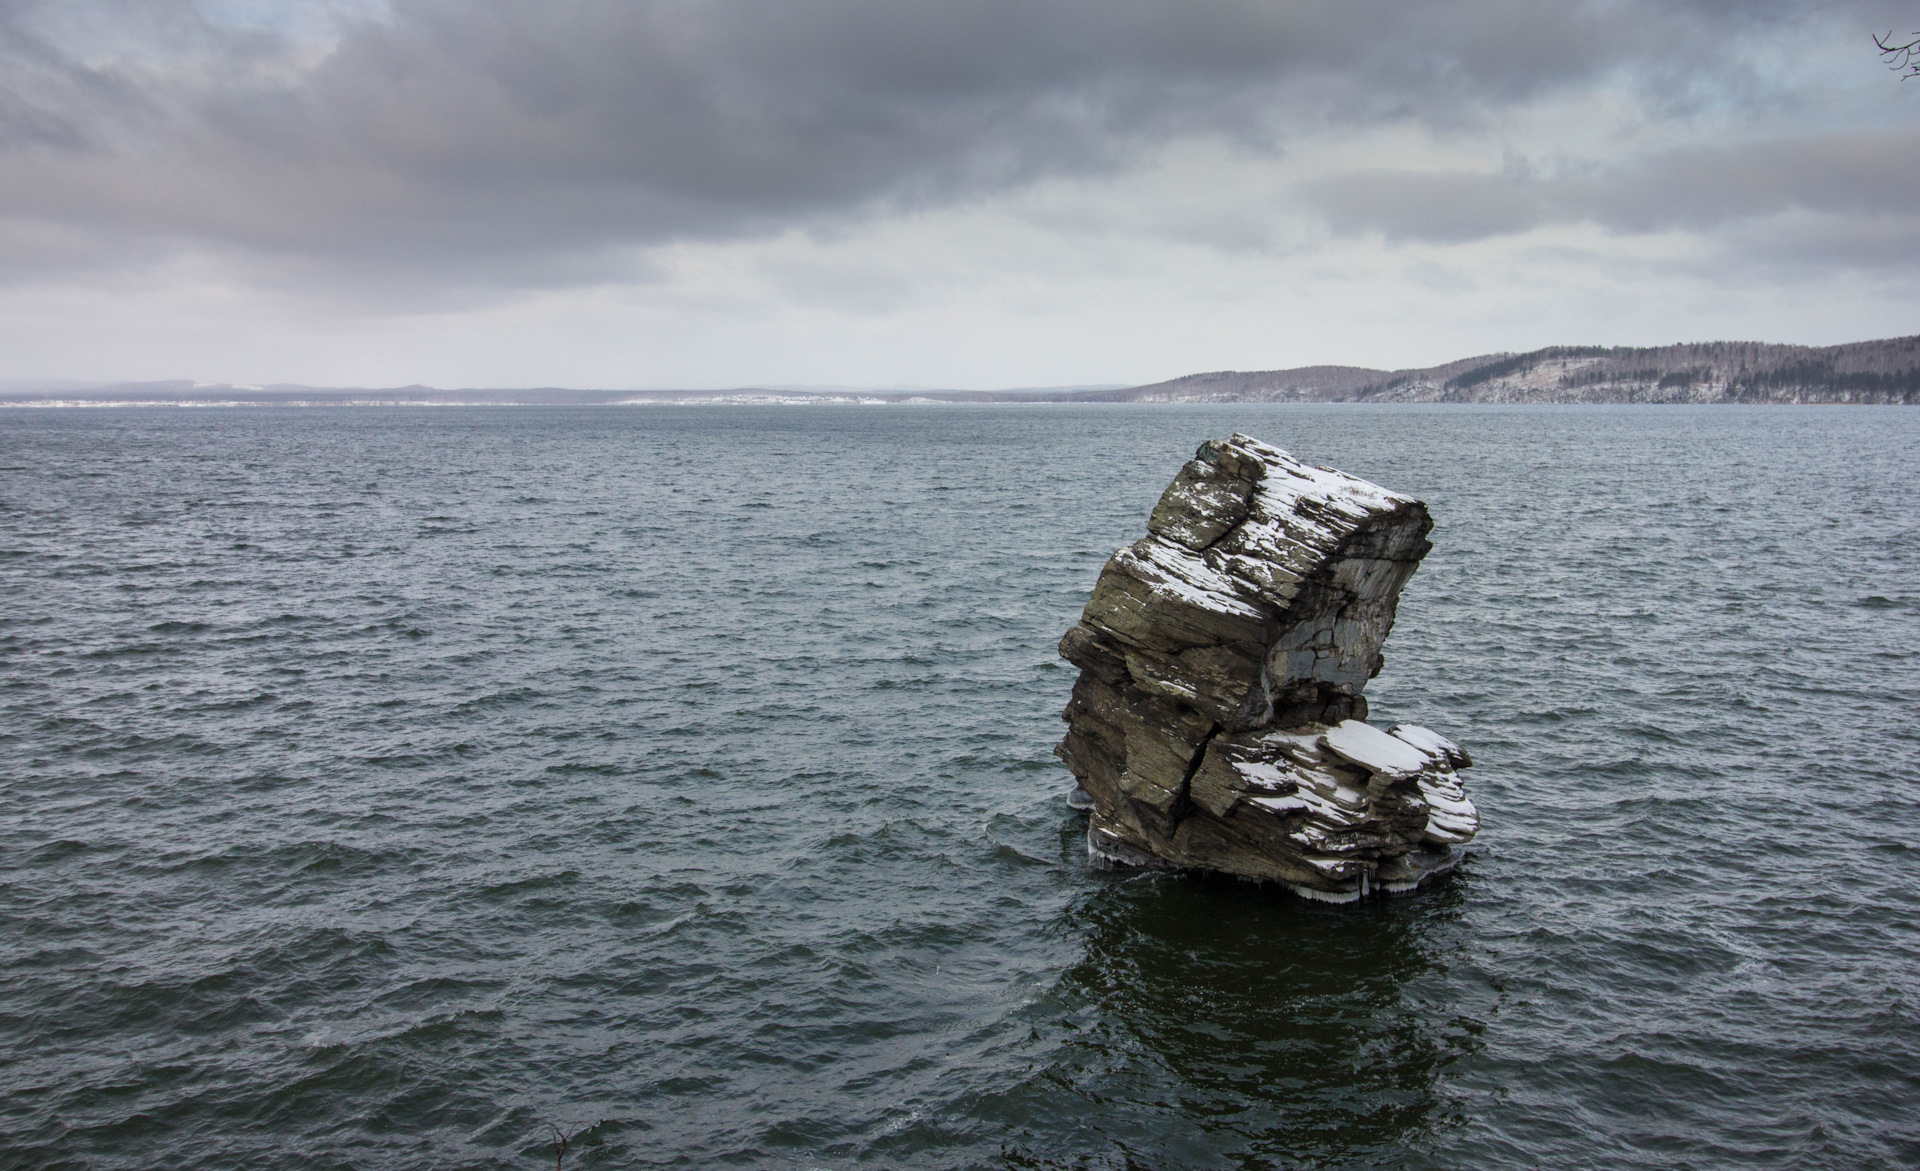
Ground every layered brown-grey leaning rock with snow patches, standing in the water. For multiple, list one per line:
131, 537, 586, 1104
1054, 434, 1478, 902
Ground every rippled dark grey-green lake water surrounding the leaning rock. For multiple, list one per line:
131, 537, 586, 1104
0, 407, 1920, 1169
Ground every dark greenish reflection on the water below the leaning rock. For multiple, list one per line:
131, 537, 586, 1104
977, 860, 1482, 1169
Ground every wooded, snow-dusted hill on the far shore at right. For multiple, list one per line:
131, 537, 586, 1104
1098, 336, 1920, 403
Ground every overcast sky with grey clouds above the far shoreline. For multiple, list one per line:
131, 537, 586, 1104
0, 0, 1920, 388
